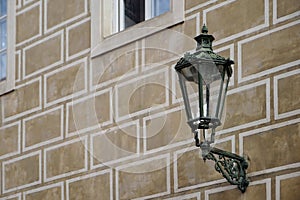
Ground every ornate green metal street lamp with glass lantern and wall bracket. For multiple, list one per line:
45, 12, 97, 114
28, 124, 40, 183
175, 25, 249, 192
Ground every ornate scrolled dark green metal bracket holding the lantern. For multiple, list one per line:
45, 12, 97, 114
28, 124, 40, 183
200, 142, 249, 193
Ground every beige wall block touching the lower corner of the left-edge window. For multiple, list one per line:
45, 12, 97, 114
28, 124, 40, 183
2, 78, 42, 121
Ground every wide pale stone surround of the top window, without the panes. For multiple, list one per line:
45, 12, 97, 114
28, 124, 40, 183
91, 0, 184, 58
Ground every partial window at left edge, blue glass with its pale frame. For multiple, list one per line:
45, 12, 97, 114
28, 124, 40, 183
0, 0, 16, 95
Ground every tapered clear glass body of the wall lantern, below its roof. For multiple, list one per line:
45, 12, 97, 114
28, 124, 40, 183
178, 63, 228, 129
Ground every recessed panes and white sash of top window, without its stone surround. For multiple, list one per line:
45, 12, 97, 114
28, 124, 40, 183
103, 0, 170, 37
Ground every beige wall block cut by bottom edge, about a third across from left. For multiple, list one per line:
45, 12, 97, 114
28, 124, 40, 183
66, 170, 113, 200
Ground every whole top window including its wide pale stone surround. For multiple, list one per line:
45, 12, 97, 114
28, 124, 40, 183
91, 0, 184, 58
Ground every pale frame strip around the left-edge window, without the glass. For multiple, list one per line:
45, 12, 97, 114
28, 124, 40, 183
0, 0, 16, 95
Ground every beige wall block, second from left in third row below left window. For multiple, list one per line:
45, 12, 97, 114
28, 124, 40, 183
44, 137, 88, 181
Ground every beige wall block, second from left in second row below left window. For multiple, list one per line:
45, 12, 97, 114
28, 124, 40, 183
23, 106, 64, 150
